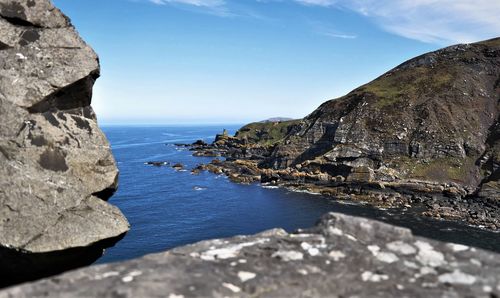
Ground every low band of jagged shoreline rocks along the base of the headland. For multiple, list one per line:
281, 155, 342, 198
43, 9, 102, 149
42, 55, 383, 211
183, 127, 500, 230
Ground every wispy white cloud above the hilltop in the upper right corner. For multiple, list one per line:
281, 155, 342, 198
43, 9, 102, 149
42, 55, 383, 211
294, 0, 500, 44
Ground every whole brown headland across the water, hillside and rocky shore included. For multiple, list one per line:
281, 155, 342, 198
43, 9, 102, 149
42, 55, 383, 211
189, 38, 500, 229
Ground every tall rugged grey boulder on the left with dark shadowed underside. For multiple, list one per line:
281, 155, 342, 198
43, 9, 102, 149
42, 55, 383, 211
0, 0, 128, 286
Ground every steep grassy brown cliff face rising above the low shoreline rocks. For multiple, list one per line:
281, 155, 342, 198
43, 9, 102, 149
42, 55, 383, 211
269, 39, 500, 191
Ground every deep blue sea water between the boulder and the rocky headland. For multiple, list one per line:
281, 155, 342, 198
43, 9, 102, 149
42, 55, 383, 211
97, 126, 500, 263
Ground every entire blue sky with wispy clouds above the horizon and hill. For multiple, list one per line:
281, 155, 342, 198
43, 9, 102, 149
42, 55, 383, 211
53, 0, 500, 124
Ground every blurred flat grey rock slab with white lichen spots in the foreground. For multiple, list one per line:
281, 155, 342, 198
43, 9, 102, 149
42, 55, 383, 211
0, 213, 500, 298
